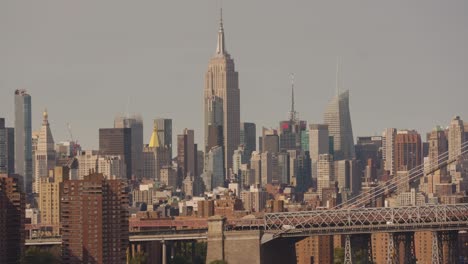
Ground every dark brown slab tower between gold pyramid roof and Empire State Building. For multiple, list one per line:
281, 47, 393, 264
177, 128, 197, 183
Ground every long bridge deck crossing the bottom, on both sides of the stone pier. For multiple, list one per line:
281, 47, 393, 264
26, 204, 468, 246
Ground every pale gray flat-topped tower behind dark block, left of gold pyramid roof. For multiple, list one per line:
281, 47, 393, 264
114, 115, 143, 179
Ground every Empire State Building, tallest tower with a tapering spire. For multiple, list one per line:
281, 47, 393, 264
204, 10, 240, 173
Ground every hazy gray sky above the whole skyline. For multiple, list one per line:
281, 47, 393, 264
0, 0, 468, 149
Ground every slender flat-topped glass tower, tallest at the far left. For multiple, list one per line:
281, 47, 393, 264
15, 90, 33, 194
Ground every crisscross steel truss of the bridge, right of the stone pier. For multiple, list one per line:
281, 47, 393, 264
264, 204, 468, 238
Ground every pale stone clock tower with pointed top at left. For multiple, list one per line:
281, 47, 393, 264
34, 110, 55, 193
